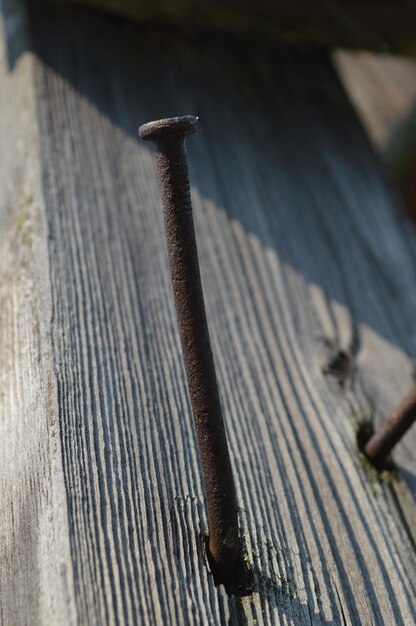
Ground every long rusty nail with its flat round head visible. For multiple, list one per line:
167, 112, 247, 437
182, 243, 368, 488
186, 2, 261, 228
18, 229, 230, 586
139, 115, 238, 584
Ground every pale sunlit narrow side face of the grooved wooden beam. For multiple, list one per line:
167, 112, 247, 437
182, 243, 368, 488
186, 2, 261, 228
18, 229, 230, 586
0, 17, 75, 626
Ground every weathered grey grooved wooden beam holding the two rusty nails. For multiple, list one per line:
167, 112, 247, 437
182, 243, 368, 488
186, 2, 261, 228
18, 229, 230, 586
0, 6, 416, 626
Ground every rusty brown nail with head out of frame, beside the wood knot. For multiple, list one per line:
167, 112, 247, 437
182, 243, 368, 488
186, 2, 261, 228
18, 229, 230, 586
363, 385, 416, 469
